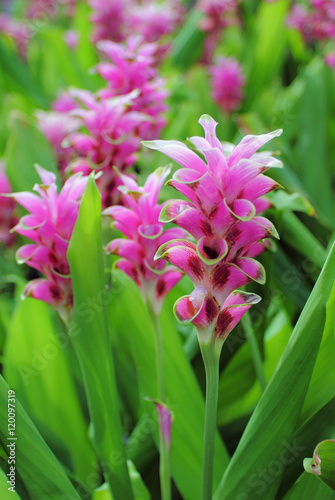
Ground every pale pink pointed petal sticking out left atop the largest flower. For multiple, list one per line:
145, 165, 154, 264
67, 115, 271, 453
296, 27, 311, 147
142, 141, 207, 175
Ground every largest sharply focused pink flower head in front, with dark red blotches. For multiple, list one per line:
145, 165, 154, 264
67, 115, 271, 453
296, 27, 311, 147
144, 115, 282, 346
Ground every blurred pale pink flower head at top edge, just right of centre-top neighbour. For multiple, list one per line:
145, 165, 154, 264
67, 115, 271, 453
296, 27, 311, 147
128, 0, 185, 42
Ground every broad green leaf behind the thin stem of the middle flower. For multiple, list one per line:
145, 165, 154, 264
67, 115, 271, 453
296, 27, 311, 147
112, 271, 229, 500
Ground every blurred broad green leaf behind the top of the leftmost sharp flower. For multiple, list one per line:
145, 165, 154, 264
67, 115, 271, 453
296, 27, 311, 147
5, 112, 60, 192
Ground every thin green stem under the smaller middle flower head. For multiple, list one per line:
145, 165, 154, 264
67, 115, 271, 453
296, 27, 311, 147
147, 300, 171, 500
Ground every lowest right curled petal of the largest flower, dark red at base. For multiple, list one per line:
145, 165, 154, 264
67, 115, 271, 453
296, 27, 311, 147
214, 290, 261, 342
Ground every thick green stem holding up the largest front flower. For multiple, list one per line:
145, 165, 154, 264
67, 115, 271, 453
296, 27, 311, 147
200, 342, 220, 500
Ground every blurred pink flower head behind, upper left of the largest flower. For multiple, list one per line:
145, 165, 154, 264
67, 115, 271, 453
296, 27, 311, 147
95, 36, 168, 139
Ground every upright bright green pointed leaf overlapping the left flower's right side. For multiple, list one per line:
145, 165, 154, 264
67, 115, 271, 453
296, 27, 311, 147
68, 174, 133, 500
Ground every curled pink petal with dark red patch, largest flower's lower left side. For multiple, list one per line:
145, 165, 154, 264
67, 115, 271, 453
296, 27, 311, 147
155, 240, 205, 286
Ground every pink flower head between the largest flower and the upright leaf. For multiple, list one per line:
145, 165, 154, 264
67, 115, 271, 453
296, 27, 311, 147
103, 168, 186, 313
